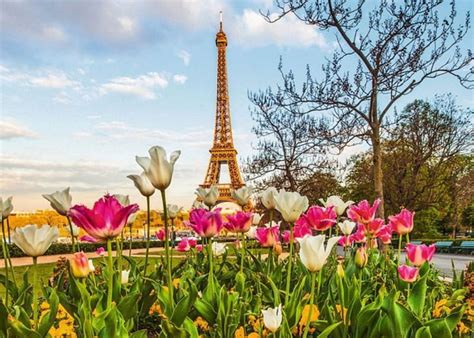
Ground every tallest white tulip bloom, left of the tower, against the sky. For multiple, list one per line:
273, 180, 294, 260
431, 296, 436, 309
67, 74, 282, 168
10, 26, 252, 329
136, 146, 181, 191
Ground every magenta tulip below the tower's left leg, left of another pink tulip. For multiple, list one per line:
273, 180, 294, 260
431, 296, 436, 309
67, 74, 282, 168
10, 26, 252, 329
185, 208, 223, 238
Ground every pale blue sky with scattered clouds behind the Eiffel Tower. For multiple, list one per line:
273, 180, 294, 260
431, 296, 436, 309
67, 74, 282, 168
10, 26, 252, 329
0, 0, 474, 211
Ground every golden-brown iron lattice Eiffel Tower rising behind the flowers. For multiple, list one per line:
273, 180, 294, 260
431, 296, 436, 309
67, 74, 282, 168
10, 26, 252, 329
201, 12, 245, 202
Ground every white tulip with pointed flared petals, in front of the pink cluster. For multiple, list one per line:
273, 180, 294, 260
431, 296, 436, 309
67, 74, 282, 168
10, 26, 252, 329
298, 235, 340, 272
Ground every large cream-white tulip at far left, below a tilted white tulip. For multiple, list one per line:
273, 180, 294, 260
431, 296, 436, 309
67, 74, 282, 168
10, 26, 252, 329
12, 224, 59, 257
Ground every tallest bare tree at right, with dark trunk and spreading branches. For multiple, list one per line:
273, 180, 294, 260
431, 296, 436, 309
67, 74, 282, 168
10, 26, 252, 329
259, 0, 474, 216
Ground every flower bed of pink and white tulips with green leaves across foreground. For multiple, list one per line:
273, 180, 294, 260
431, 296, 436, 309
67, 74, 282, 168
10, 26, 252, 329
0, 146, 474, 338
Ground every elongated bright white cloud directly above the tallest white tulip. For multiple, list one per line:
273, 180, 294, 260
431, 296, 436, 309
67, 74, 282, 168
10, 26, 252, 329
101, 72, 168, 100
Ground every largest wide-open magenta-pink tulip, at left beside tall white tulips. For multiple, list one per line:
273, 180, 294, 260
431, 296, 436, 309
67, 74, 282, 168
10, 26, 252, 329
69, 194, 138, 242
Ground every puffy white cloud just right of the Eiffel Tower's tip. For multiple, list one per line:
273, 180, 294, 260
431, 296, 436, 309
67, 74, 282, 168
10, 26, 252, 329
232, 9, 328, 48
